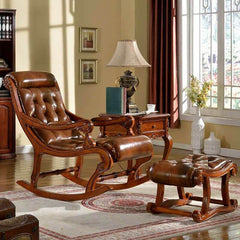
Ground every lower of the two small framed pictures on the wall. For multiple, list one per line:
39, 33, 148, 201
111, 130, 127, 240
80, 59, 97, 84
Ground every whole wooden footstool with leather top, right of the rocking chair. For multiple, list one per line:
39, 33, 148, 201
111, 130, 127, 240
147, 155, 238, 222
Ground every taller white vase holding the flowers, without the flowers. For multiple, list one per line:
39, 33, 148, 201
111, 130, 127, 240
191, 107, 205, 154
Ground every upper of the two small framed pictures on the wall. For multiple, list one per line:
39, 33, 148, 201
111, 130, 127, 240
80, 27, 97, 52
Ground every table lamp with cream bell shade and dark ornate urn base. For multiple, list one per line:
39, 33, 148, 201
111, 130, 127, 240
107, 40, 151, 113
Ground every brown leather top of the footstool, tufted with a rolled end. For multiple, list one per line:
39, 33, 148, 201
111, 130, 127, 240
148, 155, 231, 187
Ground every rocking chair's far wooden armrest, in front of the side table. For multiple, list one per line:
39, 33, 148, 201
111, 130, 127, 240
91, 116, 135, 136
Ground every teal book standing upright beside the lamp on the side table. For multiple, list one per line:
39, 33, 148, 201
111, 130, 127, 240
106, 87, 127, 114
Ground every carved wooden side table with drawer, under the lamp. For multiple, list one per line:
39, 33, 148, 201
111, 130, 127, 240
100, 113, 173, 160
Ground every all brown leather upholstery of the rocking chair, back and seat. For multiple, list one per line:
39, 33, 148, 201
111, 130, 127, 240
7, 72, 153, 162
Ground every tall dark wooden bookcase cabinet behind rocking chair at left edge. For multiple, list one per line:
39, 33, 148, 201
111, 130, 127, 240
0, 9, 16, 160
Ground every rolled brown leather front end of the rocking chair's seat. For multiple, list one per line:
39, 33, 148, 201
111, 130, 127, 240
96, 135, 153, 162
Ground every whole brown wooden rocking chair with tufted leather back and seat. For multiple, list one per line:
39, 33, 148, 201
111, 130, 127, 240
4, 71, 153, 201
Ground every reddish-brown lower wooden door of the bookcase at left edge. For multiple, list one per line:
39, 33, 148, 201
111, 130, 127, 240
0, 98, 16, 159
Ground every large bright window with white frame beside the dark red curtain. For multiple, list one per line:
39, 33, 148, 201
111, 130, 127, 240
178, 0, 240, 118
